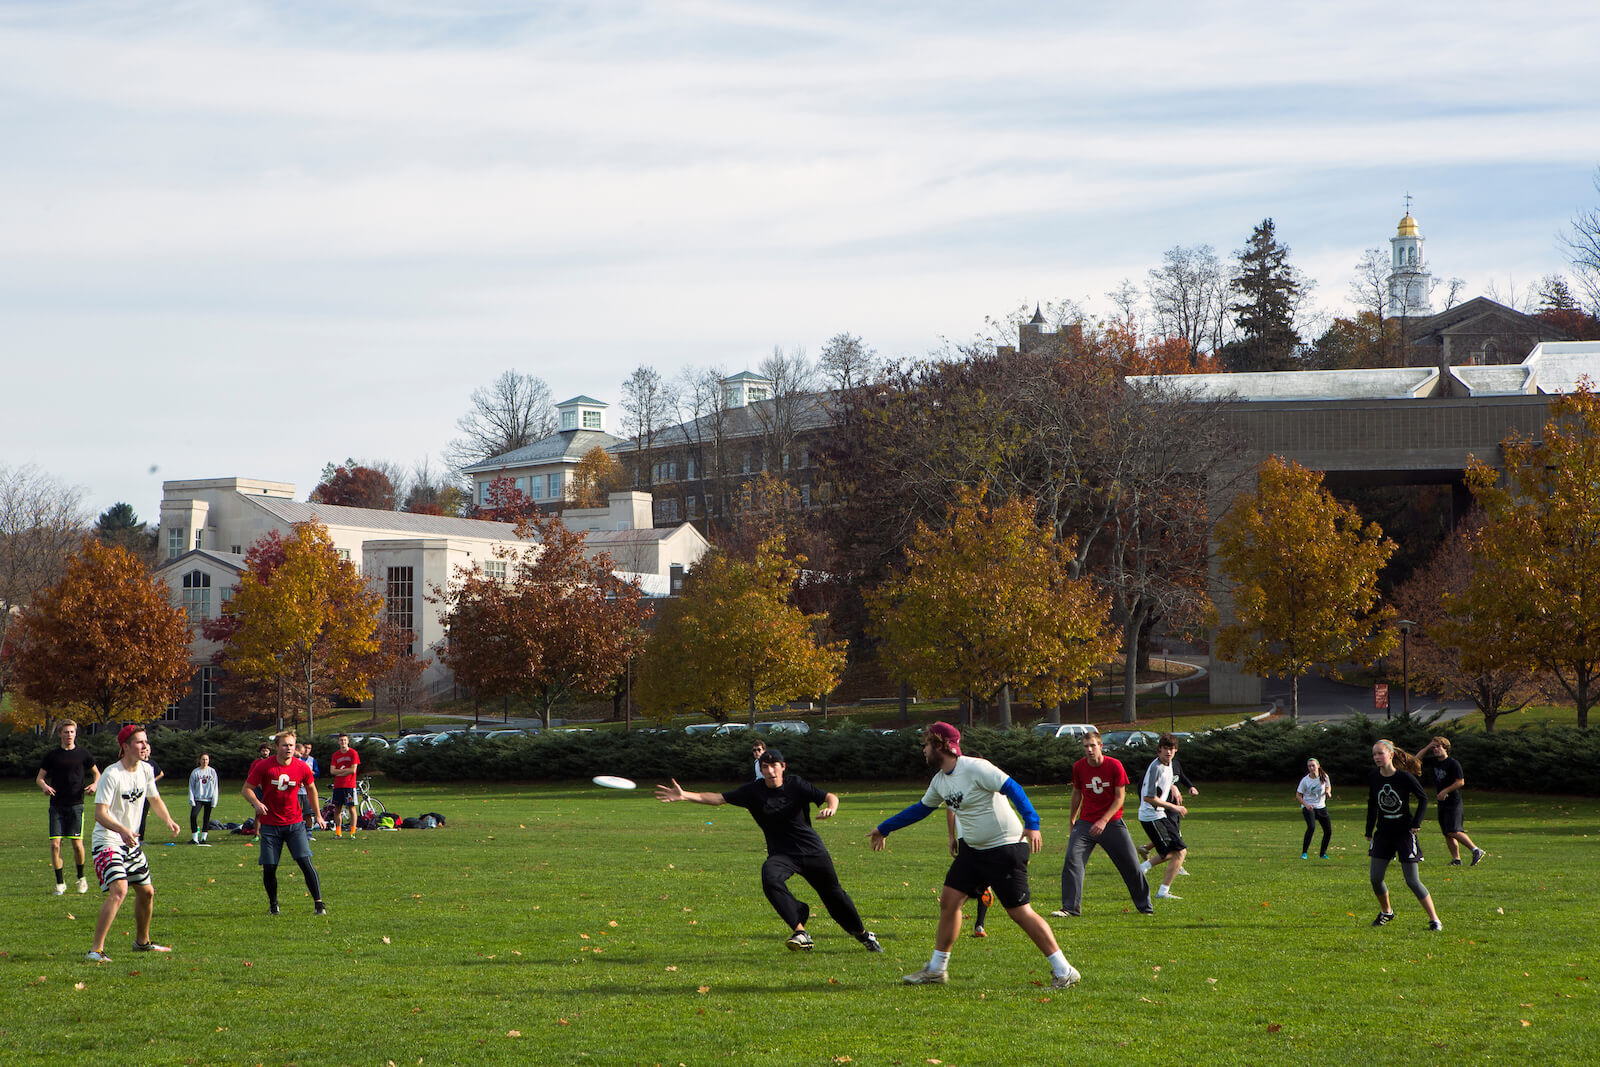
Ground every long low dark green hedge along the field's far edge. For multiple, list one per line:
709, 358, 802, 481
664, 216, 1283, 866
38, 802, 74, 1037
12, 717, 1600, 797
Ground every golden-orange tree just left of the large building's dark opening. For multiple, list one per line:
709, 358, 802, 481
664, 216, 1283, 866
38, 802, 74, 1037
1214, 456, 1397, 718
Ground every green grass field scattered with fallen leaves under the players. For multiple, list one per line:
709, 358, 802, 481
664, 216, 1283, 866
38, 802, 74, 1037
0, 768, 1600, 1067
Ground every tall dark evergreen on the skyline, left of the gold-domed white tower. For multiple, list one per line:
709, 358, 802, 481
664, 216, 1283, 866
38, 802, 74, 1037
1222, 219, 1309, 371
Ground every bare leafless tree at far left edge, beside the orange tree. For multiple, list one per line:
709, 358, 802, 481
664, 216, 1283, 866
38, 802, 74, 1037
0, 464, 88, 697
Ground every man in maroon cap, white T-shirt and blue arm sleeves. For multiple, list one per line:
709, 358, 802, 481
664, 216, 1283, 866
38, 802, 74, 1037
869, 723, 1080, 989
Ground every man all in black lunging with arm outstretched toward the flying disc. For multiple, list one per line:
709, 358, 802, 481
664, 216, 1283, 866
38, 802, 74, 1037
656, 749, 883, 952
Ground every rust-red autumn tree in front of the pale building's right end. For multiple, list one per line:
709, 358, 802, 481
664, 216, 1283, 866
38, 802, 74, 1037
430, 514, 650, 726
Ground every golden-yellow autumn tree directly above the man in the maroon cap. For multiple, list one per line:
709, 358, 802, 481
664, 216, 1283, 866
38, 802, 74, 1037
867, 488, 1117, 726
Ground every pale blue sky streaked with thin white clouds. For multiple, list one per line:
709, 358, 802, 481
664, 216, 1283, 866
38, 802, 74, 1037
0, 0, 1600, 520
